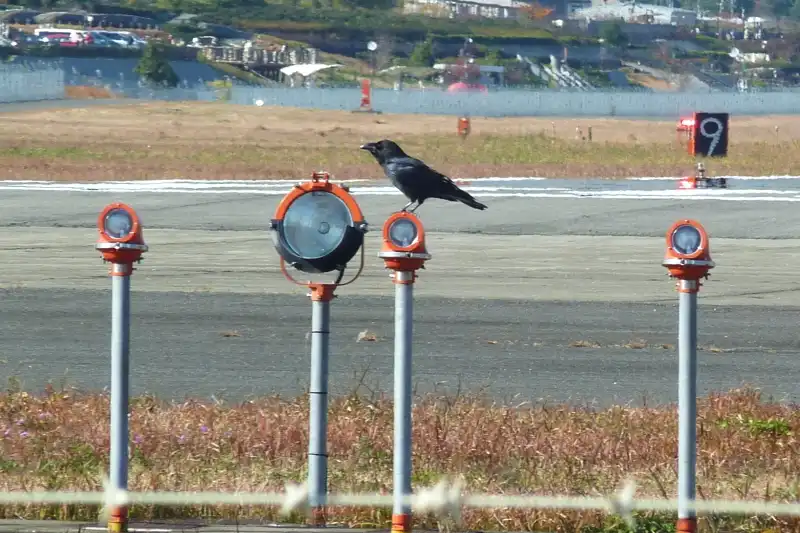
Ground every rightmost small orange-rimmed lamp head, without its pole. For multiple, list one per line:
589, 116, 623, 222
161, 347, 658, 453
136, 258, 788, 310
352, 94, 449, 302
662, 219, 714, 281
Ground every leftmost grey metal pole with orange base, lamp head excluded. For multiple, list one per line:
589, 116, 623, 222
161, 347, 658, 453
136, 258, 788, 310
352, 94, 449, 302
109, 263, 133, 531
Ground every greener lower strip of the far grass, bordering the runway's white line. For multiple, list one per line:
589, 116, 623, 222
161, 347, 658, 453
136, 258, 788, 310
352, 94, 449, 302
0, 134, 800, 181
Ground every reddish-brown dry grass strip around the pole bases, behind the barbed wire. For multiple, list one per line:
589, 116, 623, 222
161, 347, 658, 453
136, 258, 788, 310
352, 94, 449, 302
0, 389, 800, 532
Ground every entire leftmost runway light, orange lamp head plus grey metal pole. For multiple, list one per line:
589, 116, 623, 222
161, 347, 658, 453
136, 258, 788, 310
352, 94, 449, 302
95, 203, 147, 533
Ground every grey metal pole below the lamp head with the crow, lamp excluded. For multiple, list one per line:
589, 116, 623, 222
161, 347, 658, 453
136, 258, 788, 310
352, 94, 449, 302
392, 271, 414, 533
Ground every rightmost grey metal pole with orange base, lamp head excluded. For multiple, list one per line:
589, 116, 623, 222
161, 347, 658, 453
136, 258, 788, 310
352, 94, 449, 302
677, 280, 699, 532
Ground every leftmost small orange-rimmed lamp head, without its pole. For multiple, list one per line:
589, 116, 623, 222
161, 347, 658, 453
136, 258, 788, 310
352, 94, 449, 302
94, 202, 147, 265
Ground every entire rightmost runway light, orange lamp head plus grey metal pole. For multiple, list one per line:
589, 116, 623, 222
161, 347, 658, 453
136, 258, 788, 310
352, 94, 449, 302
662, 220, 715, 533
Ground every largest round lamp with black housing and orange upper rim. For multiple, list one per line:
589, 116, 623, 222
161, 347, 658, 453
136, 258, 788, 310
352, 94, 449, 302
270, 172, 368, 274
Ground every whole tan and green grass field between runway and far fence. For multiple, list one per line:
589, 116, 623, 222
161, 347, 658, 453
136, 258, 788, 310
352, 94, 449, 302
0, 100, 800, 181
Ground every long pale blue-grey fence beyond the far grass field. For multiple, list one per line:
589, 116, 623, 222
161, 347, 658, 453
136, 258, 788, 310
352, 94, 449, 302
0, 61, 800, 117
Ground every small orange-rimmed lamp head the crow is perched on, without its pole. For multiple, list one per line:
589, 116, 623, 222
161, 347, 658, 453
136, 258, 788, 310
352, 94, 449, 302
378, 211, 431, 272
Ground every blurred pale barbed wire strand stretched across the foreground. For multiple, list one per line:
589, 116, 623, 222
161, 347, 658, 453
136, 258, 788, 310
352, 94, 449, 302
0, 479, 800, 527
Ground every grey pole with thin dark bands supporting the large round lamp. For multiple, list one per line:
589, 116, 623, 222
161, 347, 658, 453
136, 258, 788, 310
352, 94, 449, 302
308, 291, 333, 525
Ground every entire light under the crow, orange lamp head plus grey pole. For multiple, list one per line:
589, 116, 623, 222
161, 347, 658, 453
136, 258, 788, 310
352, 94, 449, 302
378, 211, 431, 533
